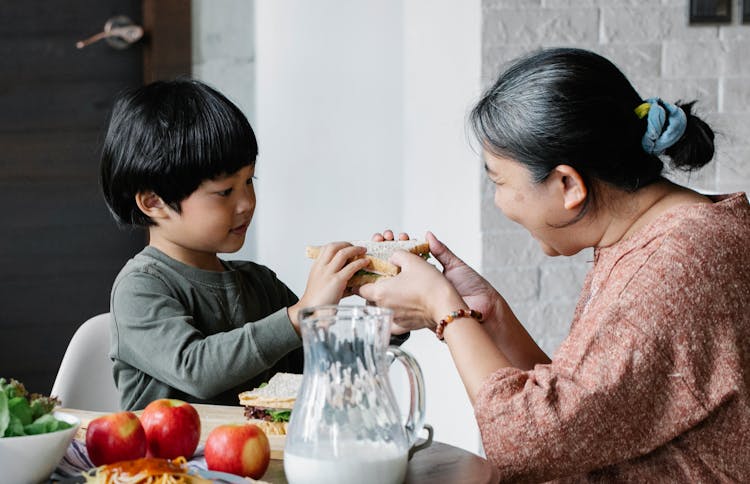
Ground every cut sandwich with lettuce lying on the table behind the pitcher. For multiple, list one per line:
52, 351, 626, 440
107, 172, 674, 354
239, 373, 302, 435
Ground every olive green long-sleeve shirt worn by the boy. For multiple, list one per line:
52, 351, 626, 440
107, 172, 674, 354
109, 246, 303, 410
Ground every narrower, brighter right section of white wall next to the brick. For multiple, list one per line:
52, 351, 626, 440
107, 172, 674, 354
403, 0, 483, 452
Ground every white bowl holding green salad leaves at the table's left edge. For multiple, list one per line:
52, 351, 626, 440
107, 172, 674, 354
0, 412, 81, 484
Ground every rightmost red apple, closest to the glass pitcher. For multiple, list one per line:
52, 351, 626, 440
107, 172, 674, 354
204, 424, 271, 479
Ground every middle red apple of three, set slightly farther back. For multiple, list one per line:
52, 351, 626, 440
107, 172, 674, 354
141, 398, 201, 459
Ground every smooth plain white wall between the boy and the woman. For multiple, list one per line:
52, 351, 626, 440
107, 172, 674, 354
254, 0, 481, 452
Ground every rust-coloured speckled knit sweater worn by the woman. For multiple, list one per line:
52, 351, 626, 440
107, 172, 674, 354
474, 193, 750, 482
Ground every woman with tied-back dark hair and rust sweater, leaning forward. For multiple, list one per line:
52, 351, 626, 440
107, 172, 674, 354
359, 49, 750, 482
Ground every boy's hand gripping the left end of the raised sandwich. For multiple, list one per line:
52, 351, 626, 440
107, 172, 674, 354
288, 242, 370, 333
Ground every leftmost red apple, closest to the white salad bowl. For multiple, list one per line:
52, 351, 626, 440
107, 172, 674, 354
86, 412, 146, 466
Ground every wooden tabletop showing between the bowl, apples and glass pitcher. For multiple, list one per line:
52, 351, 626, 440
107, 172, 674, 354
60, 404, 499, 484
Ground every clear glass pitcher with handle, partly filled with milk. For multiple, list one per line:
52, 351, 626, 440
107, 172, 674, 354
284, 306, 432, 484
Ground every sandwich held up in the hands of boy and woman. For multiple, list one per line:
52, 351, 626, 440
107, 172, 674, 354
306, 239, 430, 287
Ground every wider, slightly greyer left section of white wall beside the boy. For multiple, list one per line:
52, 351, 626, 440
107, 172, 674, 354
254, 0, 403, 276
